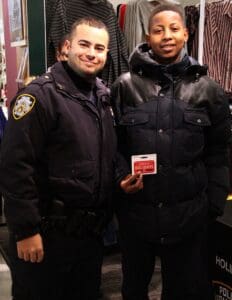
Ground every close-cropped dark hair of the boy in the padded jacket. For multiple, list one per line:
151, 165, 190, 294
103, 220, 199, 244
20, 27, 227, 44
148, 3, 185, 32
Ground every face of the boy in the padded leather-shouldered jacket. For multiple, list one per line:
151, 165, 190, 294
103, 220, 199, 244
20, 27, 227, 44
147, 10, 188, 64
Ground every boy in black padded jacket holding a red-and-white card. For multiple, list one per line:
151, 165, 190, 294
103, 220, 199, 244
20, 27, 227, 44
112, 4, 231, 300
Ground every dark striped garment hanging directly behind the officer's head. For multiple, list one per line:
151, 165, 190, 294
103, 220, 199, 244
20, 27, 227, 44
47, 0, 128, 86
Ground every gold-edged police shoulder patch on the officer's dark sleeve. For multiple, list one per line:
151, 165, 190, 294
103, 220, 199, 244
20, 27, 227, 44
12, 94, 36, 120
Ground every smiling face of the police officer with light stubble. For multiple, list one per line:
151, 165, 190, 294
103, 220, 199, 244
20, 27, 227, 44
68, 24, 109, 77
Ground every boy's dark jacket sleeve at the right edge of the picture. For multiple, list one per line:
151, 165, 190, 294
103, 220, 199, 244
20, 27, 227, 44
205, 86, 231, 218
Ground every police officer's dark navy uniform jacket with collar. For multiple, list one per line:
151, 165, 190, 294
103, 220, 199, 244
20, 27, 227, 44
0, 63, 116, 239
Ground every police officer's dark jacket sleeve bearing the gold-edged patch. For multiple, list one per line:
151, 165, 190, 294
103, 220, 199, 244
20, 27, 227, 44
0, 90, 51, 240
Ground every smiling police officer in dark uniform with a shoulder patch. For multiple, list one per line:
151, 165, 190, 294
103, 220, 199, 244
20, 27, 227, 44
0, 18, 116, 300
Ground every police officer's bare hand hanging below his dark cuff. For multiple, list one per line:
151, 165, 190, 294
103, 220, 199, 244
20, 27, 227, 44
17, 233, 44, 263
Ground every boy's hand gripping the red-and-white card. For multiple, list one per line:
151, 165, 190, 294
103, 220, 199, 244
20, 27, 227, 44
120, 174, 143, 194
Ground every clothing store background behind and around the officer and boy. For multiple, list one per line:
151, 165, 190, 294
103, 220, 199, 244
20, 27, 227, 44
0, 0, 232, 300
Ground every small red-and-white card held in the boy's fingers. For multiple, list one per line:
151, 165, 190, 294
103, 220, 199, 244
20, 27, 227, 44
131, 154, 157, 175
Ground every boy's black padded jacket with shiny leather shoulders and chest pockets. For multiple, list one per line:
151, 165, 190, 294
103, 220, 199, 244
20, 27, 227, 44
112, 44, 231, 242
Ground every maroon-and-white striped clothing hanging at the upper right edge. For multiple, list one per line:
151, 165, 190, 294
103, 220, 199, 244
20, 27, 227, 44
203, 1, 232, 92
